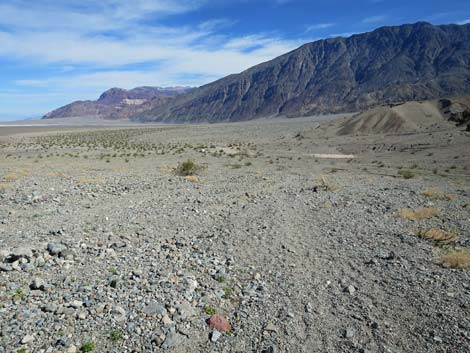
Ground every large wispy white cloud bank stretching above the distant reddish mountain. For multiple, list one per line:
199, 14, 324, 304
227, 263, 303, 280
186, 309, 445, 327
0, 0, 301, 115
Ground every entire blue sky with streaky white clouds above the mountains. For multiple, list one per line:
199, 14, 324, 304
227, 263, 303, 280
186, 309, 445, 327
0, 0, 470, 120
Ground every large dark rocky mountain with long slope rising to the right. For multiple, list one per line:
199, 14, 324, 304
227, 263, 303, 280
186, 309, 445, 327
132, 22, 470, 122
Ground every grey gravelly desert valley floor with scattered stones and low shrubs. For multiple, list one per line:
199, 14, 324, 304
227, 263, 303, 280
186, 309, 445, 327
0, 117, 470, 353
